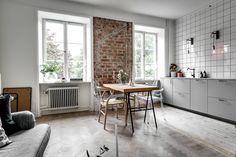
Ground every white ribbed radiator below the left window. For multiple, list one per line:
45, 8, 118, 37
47, 87, 79, 110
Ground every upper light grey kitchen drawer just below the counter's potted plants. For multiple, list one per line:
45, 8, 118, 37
173, 78, 190, 93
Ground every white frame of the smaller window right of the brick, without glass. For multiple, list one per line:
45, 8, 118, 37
133, 30, 158, 81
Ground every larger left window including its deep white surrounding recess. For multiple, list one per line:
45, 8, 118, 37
38, 11, 92, 82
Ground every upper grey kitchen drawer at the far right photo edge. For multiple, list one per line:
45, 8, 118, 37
208, 80, 236, 100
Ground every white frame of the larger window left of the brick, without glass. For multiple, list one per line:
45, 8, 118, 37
42, 18, 87, 80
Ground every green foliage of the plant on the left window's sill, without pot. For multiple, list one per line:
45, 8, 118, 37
40, 62, 62, 75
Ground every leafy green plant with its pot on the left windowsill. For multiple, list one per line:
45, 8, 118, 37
40, 62, 62, 82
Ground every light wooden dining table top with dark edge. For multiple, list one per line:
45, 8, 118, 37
103, 84, 159, 93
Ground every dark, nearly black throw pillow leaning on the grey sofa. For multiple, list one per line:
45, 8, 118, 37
0, 95, 19, 135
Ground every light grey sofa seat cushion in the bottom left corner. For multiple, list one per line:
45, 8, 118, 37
0, 124, 51, 157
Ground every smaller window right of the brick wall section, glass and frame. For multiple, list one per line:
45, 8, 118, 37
134, 31, 157, 80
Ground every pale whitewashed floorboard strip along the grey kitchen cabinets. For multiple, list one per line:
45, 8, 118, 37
157, 107, 236, 156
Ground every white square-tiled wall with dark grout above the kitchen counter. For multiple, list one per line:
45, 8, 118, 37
176, 0, 236, 78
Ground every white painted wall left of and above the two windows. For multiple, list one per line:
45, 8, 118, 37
0, 0, 173, 113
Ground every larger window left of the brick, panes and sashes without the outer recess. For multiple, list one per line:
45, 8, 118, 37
43, 19, 86, 79
